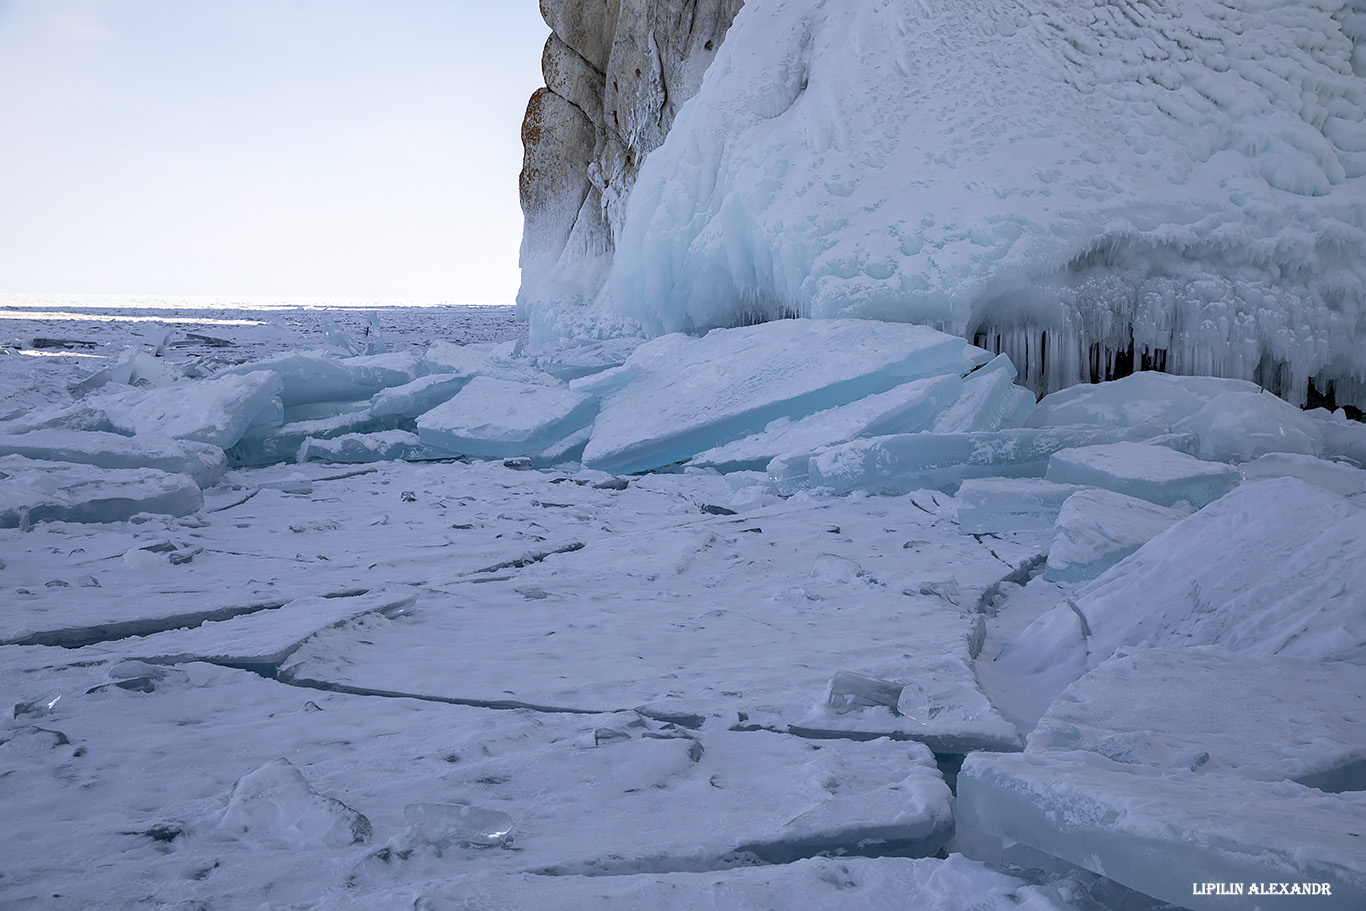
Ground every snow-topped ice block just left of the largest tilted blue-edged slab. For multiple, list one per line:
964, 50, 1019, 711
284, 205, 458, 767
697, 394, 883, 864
418, 377, 598, 459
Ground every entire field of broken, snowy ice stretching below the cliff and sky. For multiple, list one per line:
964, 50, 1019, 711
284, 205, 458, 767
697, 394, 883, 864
0, 298, 1366, 911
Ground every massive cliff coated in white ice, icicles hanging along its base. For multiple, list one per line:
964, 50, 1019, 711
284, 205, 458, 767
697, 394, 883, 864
520, 0, 1366, 404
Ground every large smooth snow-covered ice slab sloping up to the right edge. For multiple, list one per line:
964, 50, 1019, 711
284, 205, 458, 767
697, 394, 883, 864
1000, 478, 1366, 677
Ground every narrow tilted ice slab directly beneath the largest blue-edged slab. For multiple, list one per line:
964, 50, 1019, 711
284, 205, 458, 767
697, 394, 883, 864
691, 374, 964, 471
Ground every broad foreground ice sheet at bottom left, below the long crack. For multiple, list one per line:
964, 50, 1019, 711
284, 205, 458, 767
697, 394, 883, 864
0, 663, 961, 907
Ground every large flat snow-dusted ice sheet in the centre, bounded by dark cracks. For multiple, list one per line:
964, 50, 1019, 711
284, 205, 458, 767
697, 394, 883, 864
285, 488, 1045, 751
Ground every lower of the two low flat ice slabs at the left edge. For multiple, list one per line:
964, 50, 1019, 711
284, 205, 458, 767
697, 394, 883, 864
0, 455, 204, 529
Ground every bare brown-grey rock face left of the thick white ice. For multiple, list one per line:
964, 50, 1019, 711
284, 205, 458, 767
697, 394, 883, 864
518, 0, 743, 337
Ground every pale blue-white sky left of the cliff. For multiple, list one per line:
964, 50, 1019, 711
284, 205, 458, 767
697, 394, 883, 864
0, 0, 549, 300
